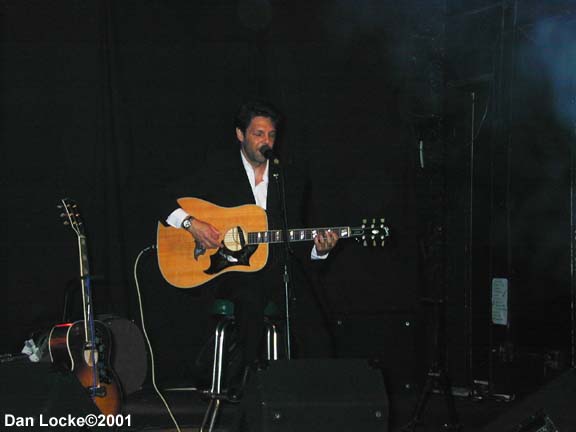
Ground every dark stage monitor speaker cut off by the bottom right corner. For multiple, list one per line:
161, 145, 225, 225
482, 369, 576, 432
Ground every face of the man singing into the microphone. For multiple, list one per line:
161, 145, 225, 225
236, 116, 276, 166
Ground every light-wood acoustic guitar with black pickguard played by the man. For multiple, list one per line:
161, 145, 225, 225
156, 198, 389, 288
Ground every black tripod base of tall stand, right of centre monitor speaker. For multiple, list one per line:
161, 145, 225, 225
401, 298, 461, 432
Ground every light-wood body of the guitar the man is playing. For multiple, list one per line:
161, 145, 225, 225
156, 198, 268, 288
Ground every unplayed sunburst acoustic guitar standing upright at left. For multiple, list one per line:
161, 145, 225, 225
48, 199, 122, 414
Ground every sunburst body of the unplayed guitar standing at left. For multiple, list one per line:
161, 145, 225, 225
48, 321, 122, 414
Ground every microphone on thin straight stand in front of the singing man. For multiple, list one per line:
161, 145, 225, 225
262, 148, 292, 360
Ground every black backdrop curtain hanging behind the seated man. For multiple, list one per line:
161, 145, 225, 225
0, 0, 418, 384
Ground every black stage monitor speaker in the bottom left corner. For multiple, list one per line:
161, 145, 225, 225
0, 359, 102, 431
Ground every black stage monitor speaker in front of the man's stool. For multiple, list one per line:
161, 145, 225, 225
241, 360, 388, 432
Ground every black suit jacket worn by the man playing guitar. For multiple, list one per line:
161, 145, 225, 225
161, 146, 312, 302
